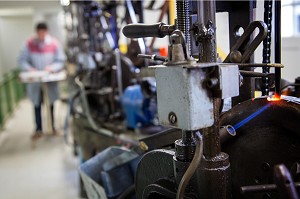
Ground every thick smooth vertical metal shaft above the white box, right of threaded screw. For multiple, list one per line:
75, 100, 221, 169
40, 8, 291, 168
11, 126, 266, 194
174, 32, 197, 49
197, 0, 217, 62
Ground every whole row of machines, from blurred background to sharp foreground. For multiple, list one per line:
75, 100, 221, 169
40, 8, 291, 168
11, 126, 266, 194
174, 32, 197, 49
65, 0, 300, 199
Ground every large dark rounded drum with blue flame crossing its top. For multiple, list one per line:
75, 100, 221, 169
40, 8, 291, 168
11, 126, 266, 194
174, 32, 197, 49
220, 96, 300, 199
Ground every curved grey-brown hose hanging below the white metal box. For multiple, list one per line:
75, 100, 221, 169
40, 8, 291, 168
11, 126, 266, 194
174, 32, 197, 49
176, 131, 203, 199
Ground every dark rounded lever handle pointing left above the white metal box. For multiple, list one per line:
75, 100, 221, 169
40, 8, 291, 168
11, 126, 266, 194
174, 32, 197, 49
122, 22, 175, 38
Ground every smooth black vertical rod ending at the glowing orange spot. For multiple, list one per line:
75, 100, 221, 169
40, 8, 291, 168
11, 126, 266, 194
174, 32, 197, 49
274, 0, 281, 95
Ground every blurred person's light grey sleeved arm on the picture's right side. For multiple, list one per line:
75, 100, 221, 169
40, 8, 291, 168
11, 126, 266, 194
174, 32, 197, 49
45, 44, 66, 72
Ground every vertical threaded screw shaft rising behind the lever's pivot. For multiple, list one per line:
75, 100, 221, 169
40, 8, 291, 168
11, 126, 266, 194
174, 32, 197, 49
176, 0, 191, 53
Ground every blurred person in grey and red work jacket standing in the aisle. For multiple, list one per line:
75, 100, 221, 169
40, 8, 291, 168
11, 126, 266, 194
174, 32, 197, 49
18, 22, 66, 139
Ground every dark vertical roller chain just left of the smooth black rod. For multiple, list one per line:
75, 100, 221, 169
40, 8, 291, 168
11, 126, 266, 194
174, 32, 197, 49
261, 0, 273, 96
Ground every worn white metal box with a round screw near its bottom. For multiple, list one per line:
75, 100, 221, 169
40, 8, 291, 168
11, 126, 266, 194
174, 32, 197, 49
155, 66, 214, 130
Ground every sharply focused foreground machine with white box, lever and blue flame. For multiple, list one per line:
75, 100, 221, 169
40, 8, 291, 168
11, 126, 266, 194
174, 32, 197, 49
122, 0, 300, 199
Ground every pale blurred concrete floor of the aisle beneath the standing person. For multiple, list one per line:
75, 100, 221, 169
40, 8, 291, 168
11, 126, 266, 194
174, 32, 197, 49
0, 100, 79, 199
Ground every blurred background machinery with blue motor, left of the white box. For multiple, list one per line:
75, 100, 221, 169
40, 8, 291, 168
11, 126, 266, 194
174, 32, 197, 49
64, 0, 165, 196
